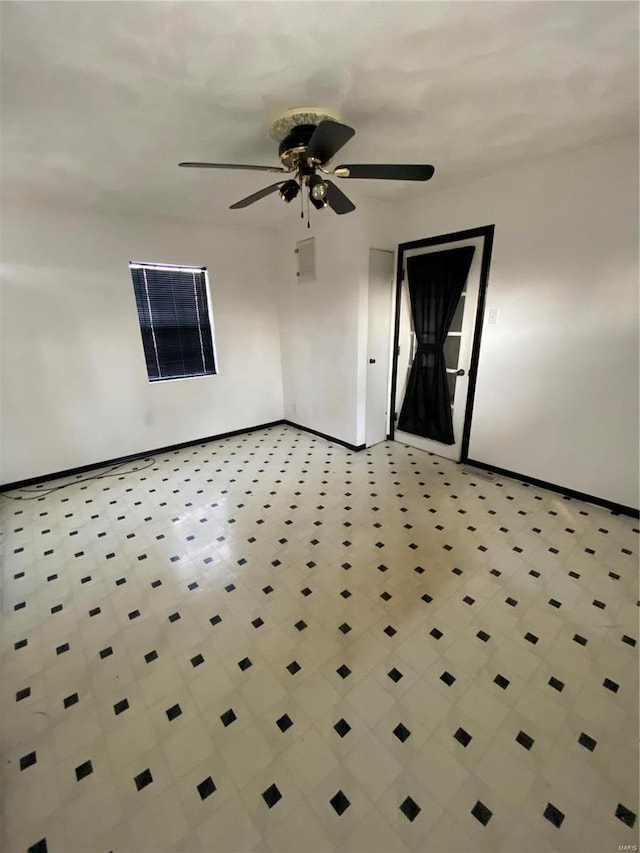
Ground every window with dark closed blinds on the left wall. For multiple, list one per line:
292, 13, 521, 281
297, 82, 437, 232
129, 263, 216, 382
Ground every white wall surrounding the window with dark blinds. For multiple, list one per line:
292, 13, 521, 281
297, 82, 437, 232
0, 206, 283, 483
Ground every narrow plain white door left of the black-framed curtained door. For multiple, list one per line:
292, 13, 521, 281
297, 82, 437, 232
365, 249, 393, 447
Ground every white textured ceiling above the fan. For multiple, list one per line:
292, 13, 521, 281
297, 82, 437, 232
1, 0, 638, 226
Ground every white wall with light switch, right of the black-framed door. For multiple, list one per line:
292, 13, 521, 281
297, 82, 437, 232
401, 133, 639, 507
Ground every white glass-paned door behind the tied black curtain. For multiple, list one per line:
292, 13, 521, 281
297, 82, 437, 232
394, 236, 484, 461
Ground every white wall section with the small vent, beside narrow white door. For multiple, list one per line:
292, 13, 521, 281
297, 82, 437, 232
278, 196, 397, 445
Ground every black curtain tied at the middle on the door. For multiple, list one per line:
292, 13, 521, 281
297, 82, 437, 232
398, 246, 474, 444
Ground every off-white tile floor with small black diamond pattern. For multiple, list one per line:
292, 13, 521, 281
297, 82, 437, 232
0, 426, 638, 853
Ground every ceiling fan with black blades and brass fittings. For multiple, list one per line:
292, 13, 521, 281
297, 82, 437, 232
178, 107, 435, 216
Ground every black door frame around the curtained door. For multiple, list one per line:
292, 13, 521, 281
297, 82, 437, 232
389, 225, 495, 462
